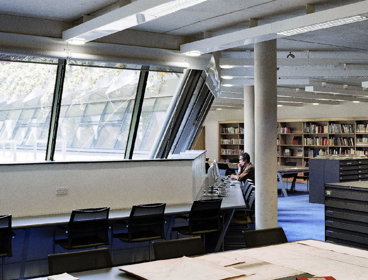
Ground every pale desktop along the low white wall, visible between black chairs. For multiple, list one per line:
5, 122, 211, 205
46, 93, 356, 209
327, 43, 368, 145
12, 184, 245, 229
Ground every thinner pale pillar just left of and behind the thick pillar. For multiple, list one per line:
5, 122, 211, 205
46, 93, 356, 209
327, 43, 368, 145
244, 86, 255, 164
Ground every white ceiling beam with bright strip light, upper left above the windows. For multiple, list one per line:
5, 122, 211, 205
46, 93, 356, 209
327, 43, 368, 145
63, 0, 208, 42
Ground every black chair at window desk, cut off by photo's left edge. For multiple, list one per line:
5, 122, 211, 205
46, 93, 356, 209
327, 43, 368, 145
0, 215, 14, 279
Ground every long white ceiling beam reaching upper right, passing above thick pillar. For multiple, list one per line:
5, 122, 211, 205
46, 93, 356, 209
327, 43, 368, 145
180, 0, 368, 53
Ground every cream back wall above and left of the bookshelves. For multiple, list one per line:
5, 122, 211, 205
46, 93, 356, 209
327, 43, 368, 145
204, 102, 368, 160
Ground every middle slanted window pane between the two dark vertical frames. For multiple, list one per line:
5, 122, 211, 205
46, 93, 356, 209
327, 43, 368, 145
54, 65, 140, 161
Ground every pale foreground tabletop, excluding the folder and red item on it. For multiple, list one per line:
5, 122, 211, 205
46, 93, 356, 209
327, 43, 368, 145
32, 240, 368, 280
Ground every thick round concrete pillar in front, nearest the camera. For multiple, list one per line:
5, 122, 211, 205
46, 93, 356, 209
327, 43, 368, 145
254, 40, 278, 229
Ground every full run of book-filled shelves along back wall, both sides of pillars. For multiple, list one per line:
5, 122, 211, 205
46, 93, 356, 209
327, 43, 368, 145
219, 118, 368, 166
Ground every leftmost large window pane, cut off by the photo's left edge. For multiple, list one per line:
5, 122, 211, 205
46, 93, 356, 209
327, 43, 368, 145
0, 61, 57, 163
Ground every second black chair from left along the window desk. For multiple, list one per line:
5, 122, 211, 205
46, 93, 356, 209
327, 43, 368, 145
55, 207, 110, 250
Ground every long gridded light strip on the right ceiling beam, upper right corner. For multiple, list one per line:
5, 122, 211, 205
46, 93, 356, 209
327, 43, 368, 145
277, 16, 368, 36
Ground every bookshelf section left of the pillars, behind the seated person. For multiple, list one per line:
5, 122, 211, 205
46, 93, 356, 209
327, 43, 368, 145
219, 122, 244, 163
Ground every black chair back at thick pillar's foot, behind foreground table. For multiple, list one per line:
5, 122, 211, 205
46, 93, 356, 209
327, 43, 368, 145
244, 227, 288, 248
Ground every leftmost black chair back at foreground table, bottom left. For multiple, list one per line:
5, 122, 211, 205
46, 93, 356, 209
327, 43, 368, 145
48, 248, 112, 275
